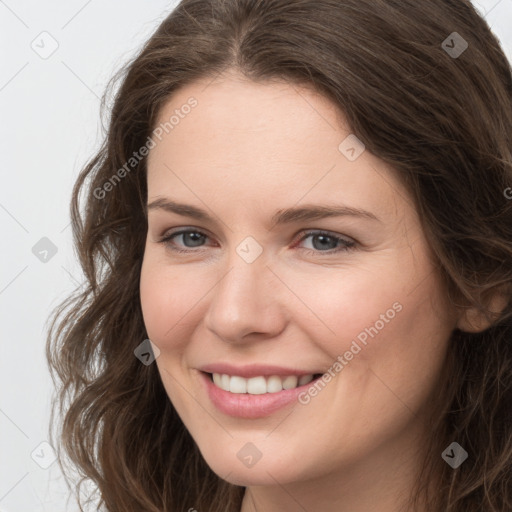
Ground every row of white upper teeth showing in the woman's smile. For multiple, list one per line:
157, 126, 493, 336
212, 373, 313, 395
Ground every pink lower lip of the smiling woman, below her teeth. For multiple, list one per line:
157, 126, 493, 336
200, 372, 316, 419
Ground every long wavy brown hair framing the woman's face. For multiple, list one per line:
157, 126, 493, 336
47, 0, 512, 512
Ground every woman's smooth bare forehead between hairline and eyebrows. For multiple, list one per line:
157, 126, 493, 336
148, 76, 406, 222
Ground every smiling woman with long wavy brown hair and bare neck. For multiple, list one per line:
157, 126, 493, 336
48, 0, 512, 512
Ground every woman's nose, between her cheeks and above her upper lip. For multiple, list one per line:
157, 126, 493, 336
204, 253, 286, 343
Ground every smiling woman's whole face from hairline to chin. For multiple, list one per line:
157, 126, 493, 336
140, 71, 456, 485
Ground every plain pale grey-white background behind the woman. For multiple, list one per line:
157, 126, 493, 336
0, 0, 512, 512
